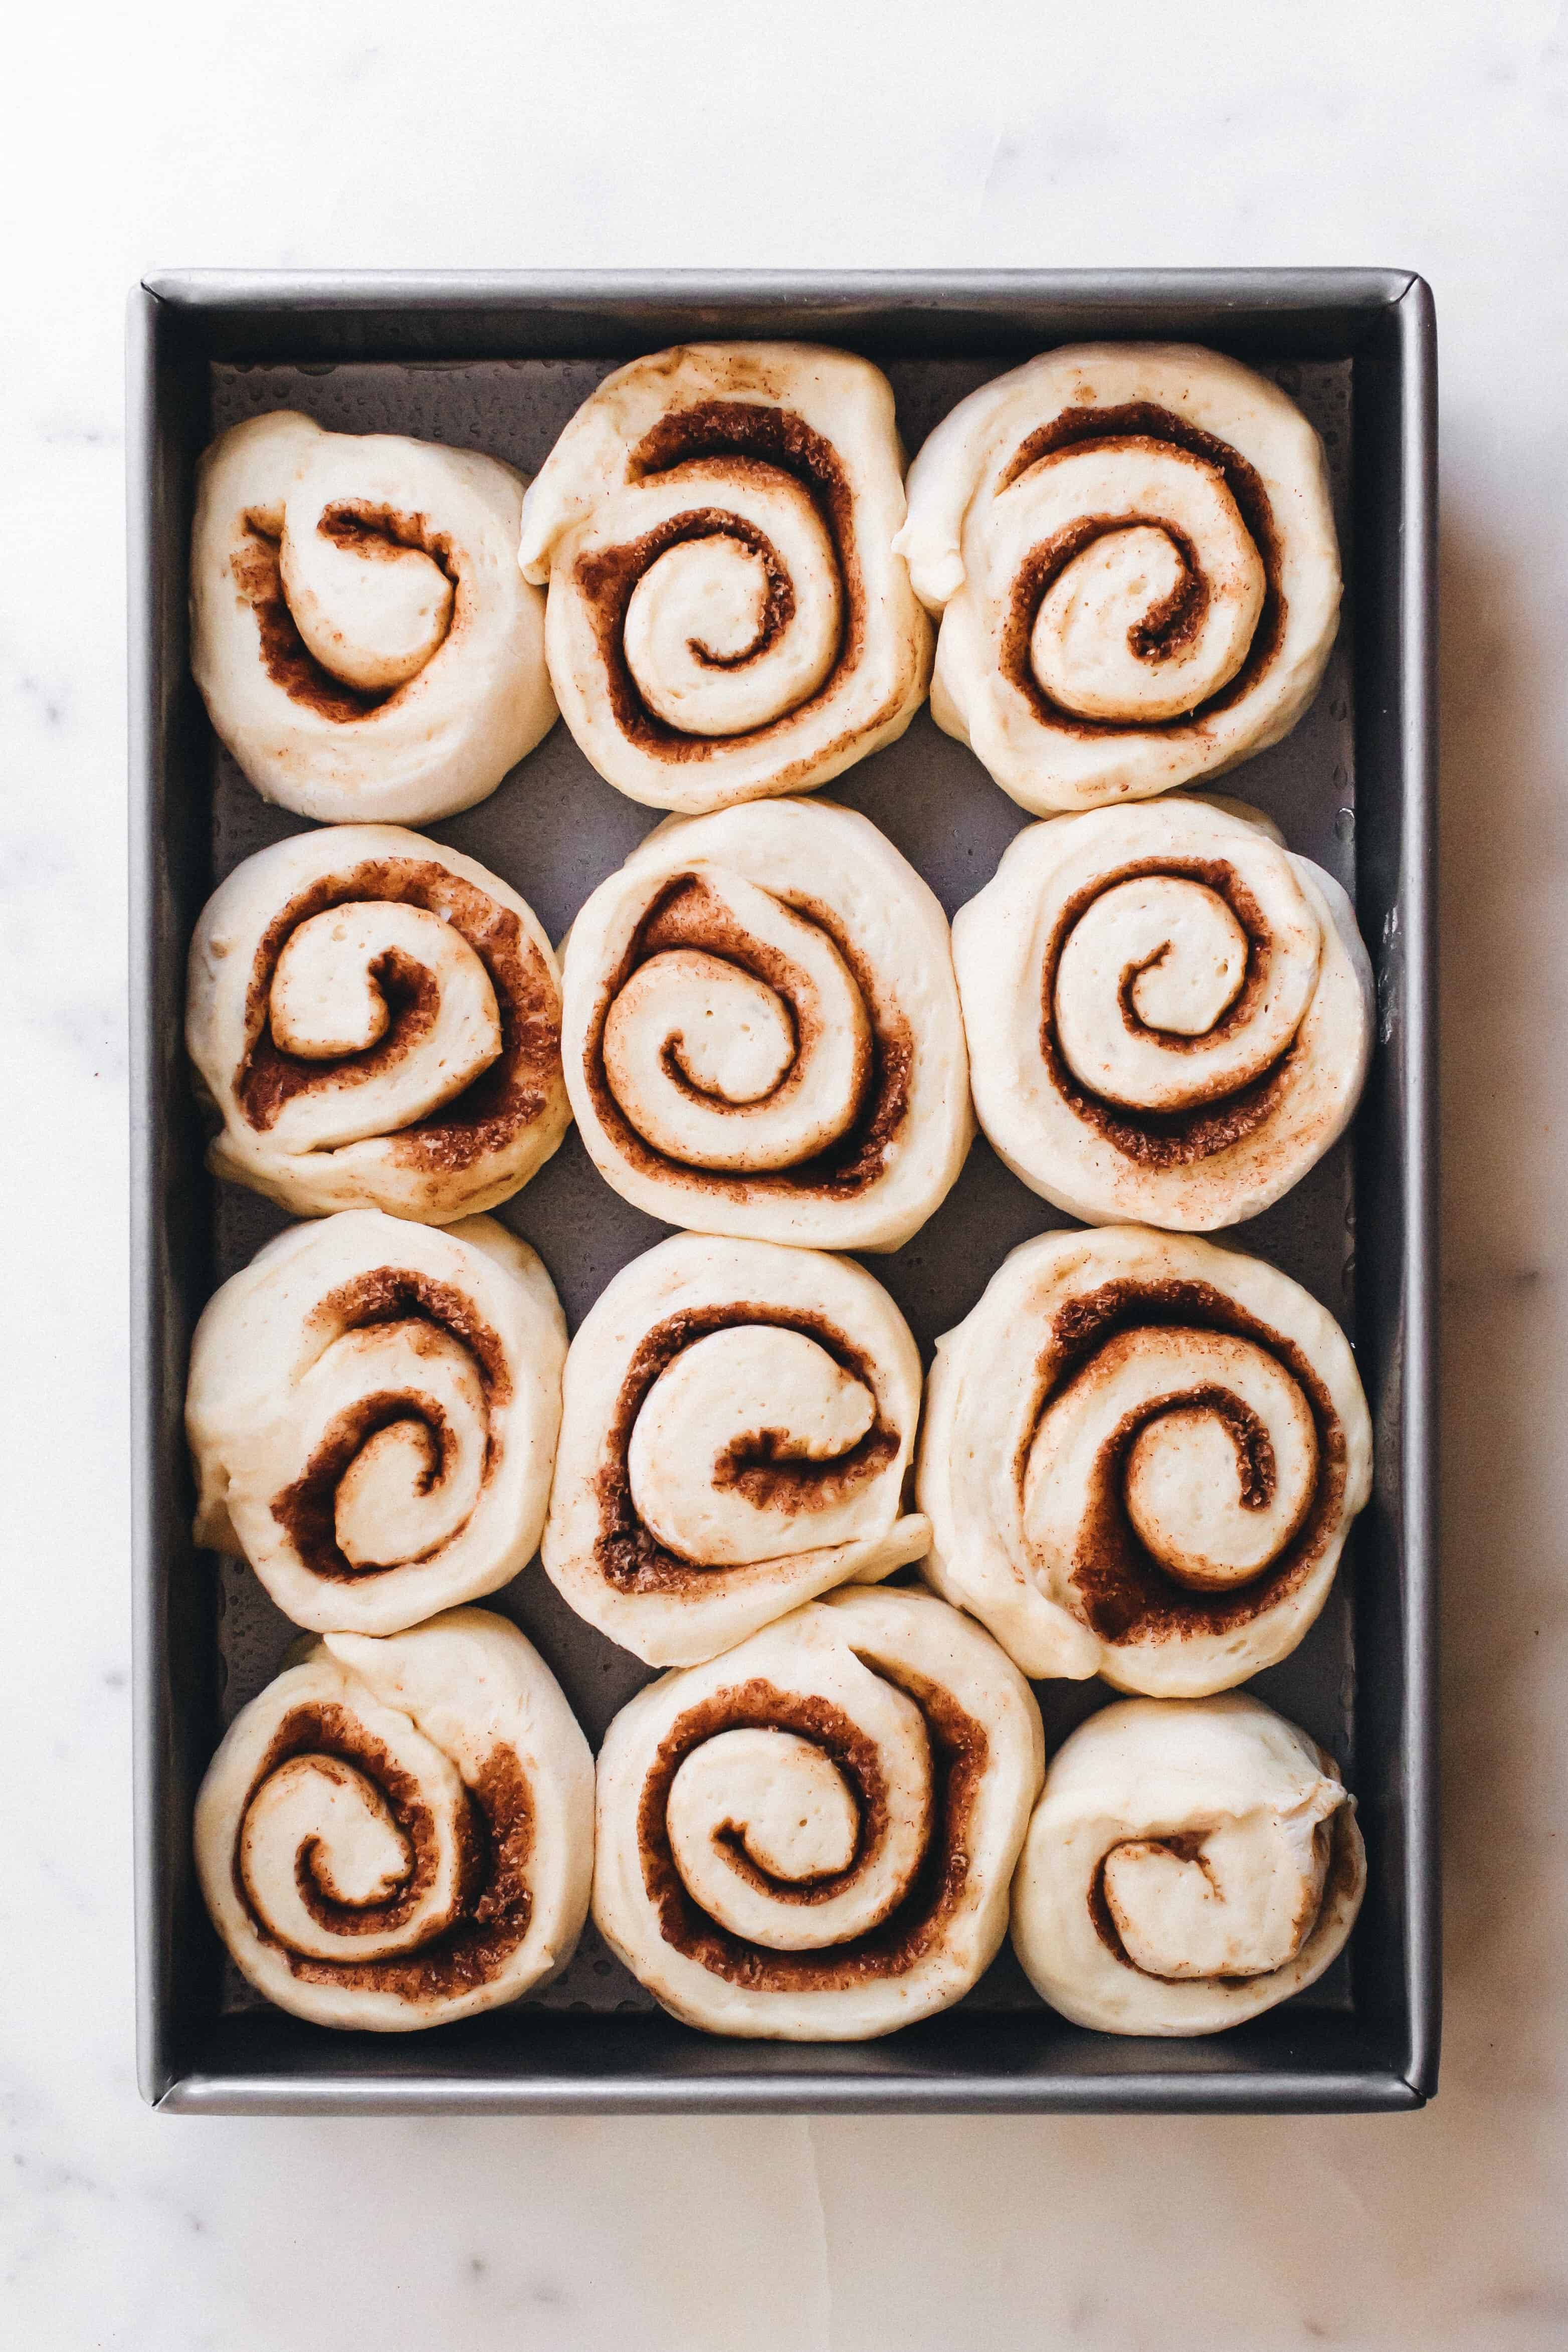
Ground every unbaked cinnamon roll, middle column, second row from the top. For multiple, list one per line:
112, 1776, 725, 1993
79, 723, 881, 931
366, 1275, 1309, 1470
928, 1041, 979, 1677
562, 800, 973, 1249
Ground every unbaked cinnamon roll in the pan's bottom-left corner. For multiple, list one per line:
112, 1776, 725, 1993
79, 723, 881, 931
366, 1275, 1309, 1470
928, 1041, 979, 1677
195, 1609, 593, 2035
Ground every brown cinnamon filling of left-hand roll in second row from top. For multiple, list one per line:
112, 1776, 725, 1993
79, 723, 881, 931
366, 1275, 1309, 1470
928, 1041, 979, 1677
235, 859, 562, 1171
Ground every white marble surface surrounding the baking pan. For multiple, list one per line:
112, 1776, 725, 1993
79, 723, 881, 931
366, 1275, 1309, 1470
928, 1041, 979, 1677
0, 0, 1568, 2352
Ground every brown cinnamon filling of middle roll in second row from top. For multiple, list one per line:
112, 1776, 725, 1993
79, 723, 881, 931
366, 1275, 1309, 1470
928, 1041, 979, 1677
583, 873, 914, 1202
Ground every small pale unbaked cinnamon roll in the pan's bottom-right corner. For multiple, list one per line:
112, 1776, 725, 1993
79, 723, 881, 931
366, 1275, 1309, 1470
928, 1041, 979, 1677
1013, 1696, 1366, 2035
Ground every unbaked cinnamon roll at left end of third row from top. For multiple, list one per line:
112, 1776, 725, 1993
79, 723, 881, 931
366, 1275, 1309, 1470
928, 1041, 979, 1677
185, 1209, 566, 1635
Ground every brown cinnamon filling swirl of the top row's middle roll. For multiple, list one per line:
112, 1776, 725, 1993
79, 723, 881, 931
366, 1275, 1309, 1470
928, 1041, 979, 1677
576, 400, 865, 760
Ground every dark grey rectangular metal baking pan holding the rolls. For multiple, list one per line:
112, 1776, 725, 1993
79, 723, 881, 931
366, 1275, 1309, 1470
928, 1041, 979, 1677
129, 271, 1439, 2112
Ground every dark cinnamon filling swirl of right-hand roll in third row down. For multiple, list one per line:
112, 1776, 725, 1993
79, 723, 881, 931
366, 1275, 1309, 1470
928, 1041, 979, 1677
1030, 1279, 1347, 1642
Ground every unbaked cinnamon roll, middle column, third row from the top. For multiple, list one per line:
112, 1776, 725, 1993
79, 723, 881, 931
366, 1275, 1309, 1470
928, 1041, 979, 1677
541, 1233, 931, 1665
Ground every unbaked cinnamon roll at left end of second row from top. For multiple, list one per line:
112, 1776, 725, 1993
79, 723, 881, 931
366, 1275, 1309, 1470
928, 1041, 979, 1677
185, 826, 571, 1226
